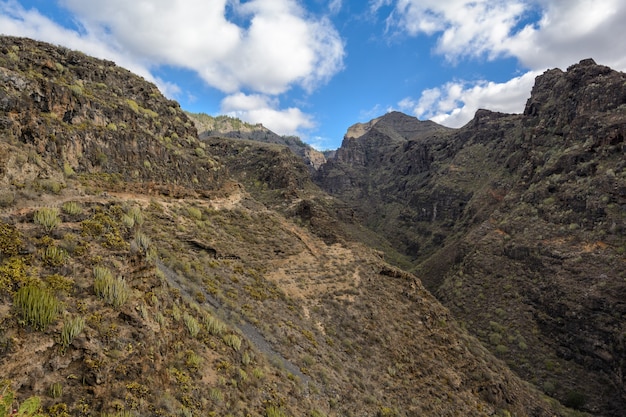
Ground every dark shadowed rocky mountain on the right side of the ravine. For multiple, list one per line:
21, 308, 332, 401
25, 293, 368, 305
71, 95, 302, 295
315, 59, 626, 416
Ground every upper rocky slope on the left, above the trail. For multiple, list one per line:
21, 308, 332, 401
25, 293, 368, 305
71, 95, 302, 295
0, 38, 220, 193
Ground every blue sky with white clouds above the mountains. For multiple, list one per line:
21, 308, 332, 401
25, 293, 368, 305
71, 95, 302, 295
0, 0, 626, 150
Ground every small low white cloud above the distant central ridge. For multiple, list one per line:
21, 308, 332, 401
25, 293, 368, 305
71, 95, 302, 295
220, 93, 315, 136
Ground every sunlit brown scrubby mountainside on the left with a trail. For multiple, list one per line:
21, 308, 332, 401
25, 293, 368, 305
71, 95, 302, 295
0, 37, 580, 416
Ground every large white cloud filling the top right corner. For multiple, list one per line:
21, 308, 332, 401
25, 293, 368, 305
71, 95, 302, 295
370, 0, 626, 70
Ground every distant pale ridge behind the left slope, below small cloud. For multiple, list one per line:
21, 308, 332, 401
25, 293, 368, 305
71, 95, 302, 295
187, 113, 326, 170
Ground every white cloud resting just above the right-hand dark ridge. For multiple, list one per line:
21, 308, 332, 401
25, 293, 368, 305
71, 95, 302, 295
398, 71, 541, 127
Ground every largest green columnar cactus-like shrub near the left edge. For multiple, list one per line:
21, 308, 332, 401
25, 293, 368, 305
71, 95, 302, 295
13, 283, 59, 330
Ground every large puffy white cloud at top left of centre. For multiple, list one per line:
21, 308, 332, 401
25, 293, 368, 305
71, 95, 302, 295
54, 0, 344, 94
